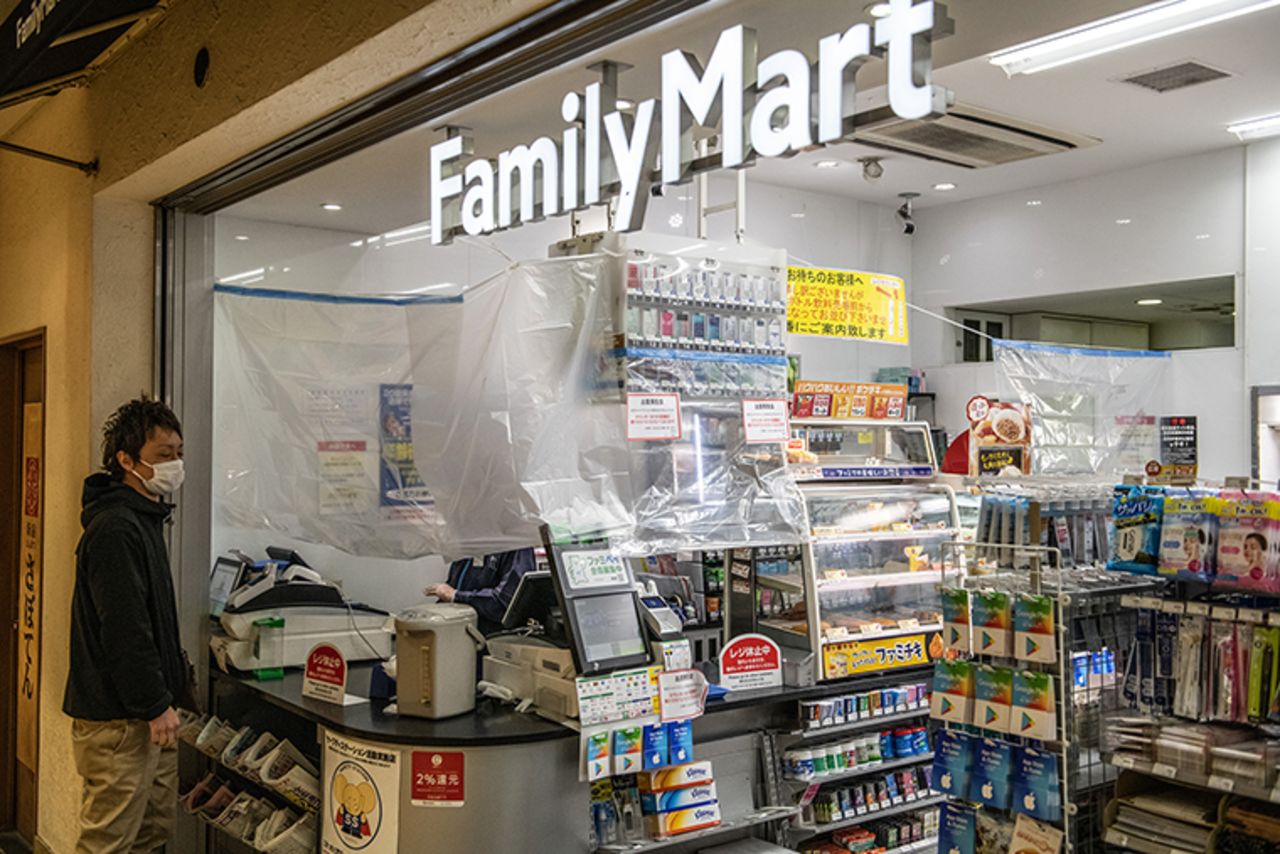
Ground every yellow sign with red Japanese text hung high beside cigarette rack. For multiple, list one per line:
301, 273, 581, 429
787, 266, 908, 344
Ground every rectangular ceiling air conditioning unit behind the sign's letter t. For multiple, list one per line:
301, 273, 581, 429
852, 102, 1101, 169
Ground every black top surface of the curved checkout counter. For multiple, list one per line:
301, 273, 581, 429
211, 662, 932, 746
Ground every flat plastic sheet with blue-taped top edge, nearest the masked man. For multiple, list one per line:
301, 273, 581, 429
214, 286, 442, 558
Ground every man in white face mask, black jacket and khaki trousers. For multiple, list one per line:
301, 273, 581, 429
63, 397, 192, 854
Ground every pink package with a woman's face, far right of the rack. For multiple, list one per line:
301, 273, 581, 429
1213, 492, 1280, 593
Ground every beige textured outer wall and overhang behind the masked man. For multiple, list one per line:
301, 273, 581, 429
0, 0, 547, 854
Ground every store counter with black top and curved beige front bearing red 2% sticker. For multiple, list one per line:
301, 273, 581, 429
210, 663, 931, 854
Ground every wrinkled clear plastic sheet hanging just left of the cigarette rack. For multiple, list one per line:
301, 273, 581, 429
406, 254, 631, 554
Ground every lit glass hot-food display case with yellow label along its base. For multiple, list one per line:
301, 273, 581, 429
755, 421, 960, 680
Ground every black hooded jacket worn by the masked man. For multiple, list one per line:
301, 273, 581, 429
63, 472, 187, 721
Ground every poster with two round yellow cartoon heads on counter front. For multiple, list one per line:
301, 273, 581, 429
320, 730, 401, 854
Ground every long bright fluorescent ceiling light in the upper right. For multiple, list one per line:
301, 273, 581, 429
988, 0, 1280, 77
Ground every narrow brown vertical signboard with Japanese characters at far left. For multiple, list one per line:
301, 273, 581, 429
17, 403, 45, 771
